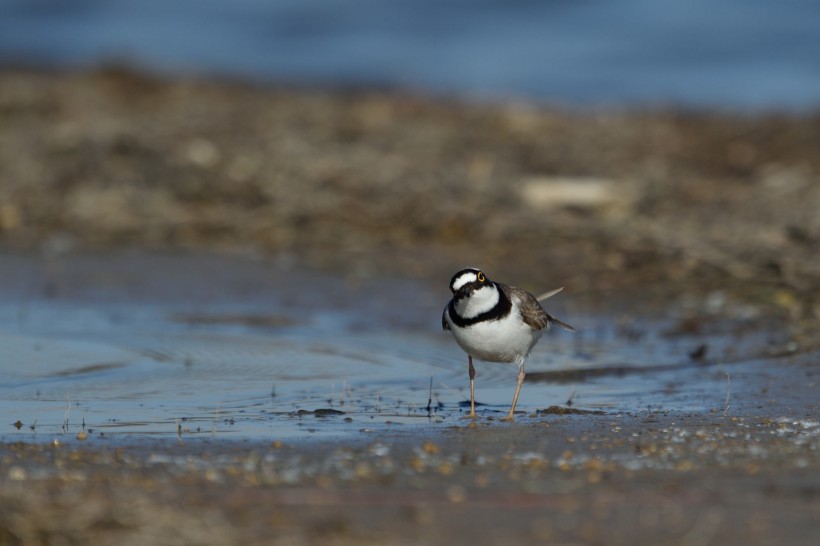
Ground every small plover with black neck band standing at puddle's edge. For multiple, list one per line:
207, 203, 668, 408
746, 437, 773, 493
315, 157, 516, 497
441, 267, 575, 421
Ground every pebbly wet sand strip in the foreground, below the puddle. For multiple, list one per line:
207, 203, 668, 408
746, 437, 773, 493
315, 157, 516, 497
0, 408, 820, 544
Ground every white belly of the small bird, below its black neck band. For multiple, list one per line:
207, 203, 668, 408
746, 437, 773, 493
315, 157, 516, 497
448, 307, 541, 362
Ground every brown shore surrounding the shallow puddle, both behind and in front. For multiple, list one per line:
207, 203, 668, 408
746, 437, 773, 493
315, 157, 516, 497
0, 70, 820, 545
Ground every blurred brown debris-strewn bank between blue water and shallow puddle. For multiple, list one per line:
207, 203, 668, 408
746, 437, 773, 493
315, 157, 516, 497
0, 69, 820, 302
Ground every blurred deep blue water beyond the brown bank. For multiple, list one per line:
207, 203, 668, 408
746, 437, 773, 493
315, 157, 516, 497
0, 0, 820, 110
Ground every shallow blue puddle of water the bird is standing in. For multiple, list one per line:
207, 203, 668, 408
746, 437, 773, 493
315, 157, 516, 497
0, 252, 792, 441
